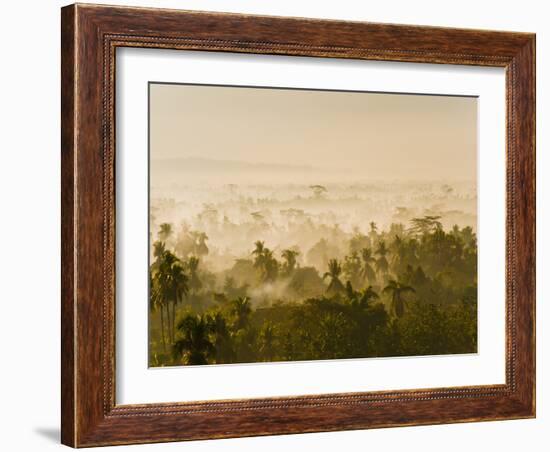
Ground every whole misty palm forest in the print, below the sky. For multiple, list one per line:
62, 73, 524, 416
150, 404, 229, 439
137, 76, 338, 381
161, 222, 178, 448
149, 177, 477, 367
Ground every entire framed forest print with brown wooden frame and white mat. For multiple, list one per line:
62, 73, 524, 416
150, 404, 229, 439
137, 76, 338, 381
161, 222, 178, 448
61, 4, 535, 447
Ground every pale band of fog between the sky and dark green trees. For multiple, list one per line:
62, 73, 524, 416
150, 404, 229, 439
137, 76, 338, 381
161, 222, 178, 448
150, 162, 477, 272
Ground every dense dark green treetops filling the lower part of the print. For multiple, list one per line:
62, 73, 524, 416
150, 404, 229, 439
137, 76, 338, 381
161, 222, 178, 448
149, 216, 477, 366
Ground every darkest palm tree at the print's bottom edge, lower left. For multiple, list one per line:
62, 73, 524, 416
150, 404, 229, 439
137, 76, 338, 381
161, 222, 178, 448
173, 314, 215, 365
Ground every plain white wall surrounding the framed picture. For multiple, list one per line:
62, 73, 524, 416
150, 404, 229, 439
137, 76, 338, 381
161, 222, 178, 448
0, 0, 550, 452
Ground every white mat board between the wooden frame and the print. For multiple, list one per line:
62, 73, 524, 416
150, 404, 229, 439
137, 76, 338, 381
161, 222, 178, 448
116, 48, 506, 404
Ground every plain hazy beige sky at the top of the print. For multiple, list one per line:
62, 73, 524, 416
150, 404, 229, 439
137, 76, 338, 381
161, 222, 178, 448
150, 84, 477, 182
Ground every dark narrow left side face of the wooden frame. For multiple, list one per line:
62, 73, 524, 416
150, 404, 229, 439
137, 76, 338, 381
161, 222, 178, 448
61, 5, 77, 447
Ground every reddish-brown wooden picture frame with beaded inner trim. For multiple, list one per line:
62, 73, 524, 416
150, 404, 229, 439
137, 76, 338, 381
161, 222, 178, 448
61, 4, 535, 447
